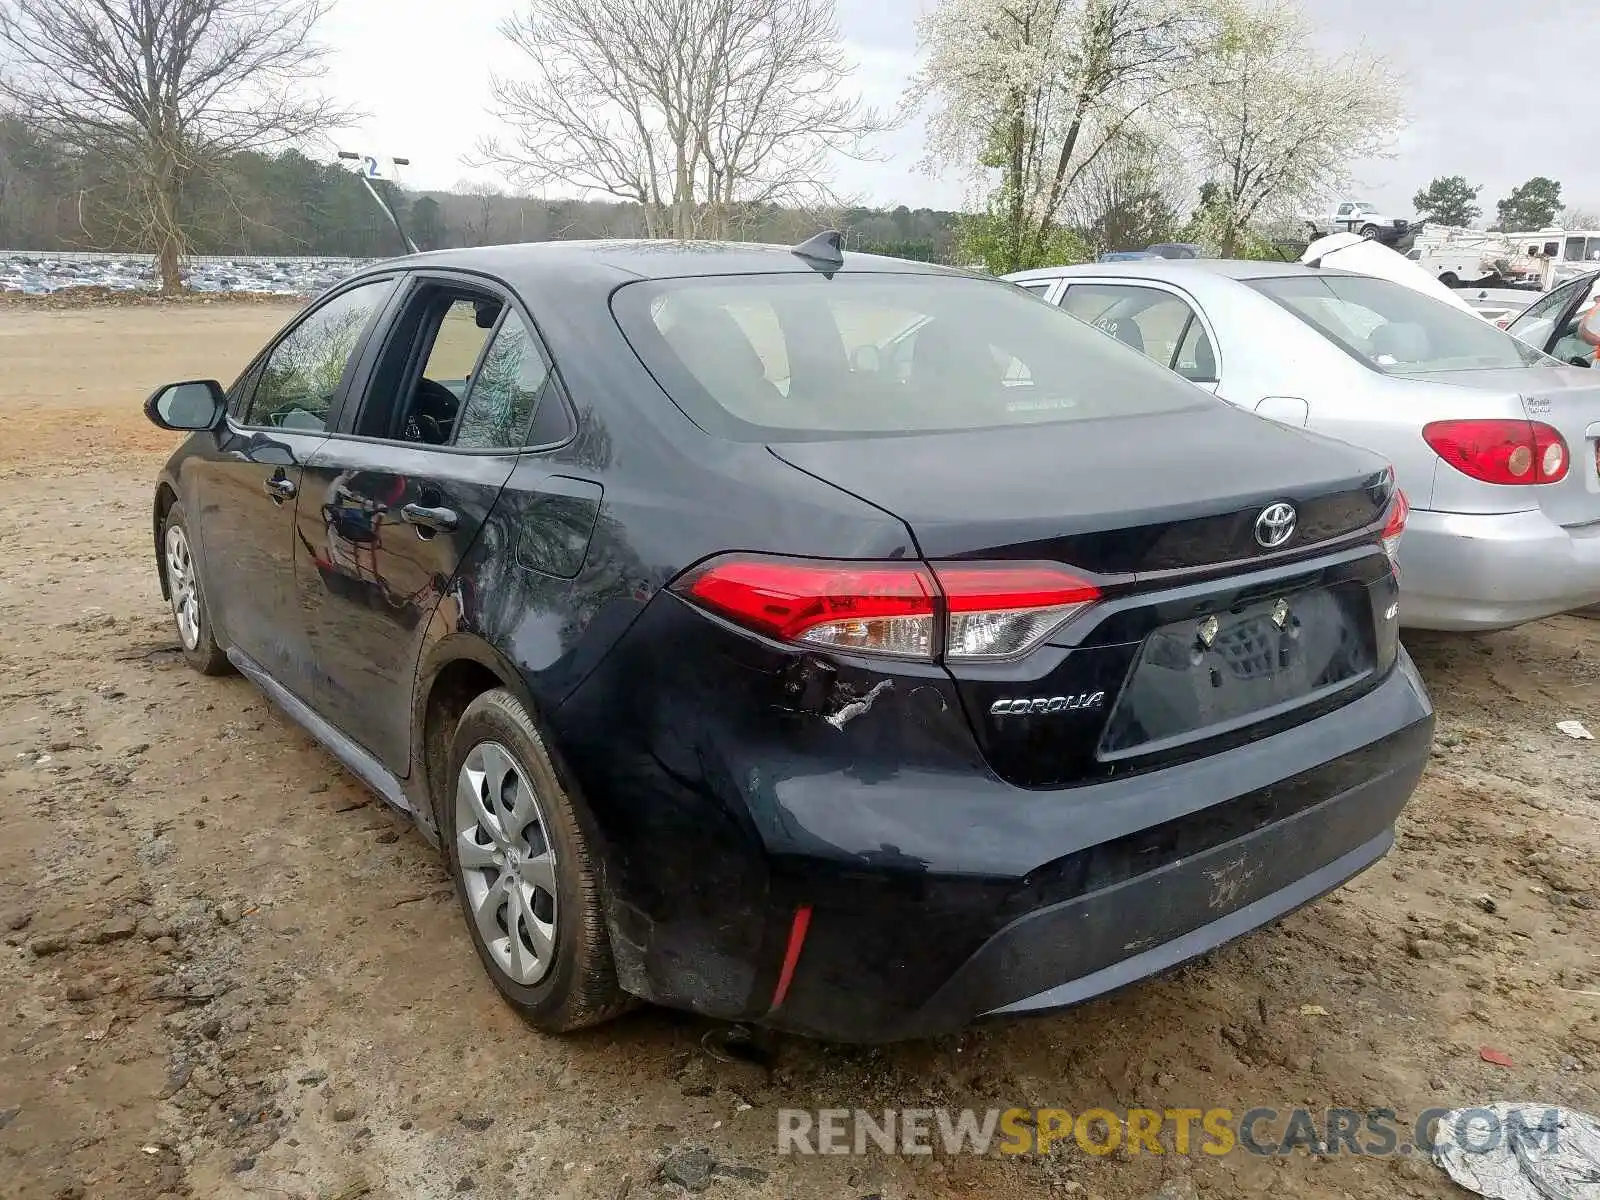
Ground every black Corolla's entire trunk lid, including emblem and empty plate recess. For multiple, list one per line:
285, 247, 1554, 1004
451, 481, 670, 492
770, 405, 1397, 787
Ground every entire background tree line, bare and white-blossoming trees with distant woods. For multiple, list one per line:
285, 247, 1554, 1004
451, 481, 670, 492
0, 0, 1405, 290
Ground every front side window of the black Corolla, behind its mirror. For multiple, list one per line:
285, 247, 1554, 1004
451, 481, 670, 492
246, 278, 395, 432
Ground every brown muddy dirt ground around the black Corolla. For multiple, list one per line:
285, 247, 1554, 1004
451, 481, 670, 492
0, 304, 1600, 1200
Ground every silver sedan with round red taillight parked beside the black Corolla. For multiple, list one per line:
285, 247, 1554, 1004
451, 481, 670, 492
1008, 259, 1600, 629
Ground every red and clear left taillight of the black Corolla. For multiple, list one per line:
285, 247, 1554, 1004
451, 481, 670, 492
674, 555, 1099, 661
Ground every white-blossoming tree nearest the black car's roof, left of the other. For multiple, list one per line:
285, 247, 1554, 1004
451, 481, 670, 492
907, 0, 1200, 272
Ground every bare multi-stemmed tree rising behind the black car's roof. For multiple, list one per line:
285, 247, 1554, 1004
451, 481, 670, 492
480, 0, 886, 237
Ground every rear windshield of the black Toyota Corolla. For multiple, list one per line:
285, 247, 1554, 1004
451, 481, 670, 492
611, 272, 1218, 442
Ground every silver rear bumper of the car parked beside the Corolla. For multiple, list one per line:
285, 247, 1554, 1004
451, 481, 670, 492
1400, 509, 1600, 630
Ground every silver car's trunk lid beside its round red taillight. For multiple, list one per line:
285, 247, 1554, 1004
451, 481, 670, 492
1405, 363, 1600, 525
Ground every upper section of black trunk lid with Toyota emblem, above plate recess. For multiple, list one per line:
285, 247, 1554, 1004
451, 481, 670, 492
770, 405, 1387, 576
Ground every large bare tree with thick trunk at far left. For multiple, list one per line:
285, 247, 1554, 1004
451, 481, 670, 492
0, 0, 350, 293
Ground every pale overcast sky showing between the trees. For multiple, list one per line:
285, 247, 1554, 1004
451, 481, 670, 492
322, 0, 1600, 224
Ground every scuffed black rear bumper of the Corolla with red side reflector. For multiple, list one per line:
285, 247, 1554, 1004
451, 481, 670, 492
558, 611, 1432, 1042
